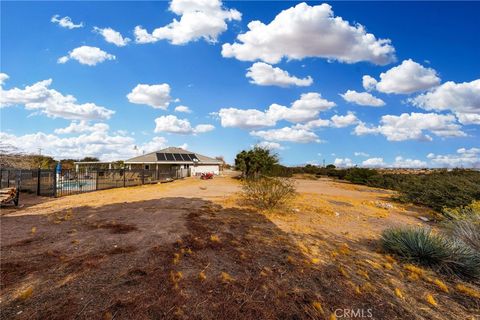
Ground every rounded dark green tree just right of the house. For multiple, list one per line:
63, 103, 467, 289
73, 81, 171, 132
235, 146, 278, 178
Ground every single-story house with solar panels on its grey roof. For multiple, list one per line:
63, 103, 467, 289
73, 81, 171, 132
124, 147, 223, 176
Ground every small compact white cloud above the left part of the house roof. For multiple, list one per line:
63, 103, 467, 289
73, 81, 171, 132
127, 83, 172, 110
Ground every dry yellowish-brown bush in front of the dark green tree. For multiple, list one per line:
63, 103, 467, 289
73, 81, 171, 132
242, 177, 295, 209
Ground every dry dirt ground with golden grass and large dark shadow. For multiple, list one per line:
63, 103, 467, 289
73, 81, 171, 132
0, 175, 480, 320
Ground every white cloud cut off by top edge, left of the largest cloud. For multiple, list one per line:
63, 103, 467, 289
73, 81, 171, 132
134, 0, 242, 45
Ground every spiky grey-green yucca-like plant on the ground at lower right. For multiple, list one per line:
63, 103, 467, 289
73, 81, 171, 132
381, 228, 480, 278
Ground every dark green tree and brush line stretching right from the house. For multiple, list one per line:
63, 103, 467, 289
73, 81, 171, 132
235, 147, 480, 212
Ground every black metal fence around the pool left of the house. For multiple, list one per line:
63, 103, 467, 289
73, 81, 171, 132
0, 168, 189, 197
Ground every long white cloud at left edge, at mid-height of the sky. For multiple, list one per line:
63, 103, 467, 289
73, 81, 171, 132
0, 75, 115, 120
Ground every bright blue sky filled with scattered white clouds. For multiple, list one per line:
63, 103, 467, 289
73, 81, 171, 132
0, 0, 480, 167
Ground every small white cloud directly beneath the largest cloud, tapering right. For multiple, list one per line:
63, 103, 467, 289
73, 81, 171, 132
246, 62, 313, 87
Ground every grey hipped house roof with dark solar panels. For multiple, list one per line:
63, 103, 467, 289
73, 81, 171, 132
125, 147, 222, 164
